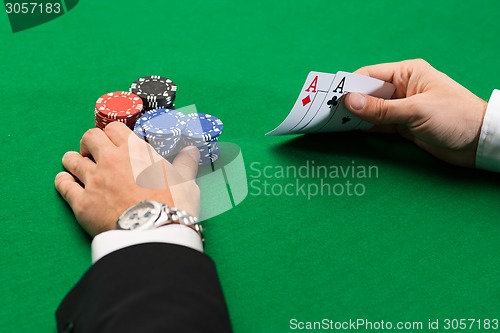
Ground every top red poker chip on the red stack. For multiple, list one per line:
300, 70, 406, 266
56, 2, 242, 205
95, 91, 143, 120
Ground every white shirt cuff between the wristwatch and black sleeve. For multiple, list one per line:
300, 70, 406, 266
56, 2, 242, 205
92, 224, 203, 264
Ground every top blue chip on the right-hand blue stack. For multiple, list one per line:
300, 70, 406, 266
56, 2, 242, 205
182, 113, 224, 141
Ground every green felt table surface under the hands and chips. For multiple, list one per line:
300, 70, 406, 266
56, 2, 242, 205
0, 0, 500, 332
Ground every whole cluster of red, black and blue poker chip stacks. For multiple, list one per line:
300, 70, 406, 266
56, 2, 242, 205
94, 76, 223, 165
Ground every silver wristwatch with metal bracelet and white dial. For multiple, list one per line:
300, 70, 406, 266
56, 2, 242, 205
116, 200, 204, 241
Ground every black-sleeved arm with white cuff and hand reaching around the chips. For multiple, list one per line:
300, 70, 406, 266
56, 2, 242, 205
55, 122, 231, 332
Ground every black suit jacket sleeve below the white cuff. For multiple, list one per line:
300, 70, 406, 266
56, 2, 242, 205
56, 243, 231, 333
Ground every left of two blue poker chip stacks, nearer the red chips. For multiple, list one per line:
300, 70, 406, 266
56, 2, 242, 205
134, 109, 186, 158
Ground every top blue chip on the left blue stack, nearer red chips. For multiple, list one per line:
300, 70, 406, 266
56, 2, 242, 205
138, 109, 186, 140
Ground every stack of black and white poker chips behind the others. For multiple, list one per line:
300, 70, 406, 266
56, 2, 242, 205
130, 75, 177, 111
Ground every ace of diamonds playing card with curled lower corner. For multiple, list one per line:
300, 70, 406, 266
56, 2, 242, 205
267, 72, 335, 135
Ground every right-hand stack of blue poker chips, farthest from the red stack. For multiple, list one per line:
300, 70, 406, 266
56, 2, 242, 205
182, 113, 223, 164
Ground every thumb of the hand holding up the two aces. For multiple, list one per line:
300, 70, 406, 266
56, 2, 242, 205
344, 93, 414, 125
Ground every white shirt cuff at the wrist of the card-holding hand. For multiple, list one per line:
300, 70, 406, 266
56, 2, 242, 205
476, 89, 500, 172
